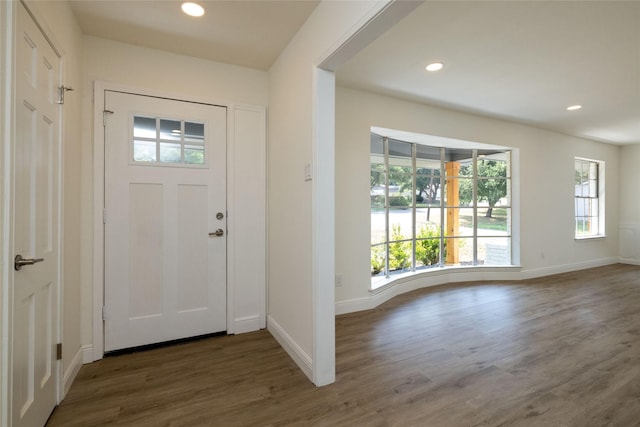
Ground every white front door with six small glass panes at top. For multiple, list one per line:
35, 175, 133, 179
104, 90, 227, 352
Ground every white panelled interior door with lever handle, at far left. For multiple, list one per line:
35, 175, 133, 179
11, 3, 60, 427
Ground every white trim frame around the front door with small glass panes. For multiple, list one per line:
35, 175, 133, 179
91, 81, 266, 363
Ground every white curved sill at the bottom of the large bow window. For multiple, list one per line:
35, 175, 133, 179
369, 265, 521, 293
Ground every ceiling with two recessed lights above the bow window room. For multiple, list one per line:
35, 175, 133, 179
337, 1, 640, 144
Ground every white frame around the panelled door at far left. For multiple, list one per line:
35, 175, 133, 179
0, 0, 65, 426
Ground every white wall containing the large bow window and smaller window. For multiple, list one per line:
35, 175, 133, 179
336, 87, 620, 312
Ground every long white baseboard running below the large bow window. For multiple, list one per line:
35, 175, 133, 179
336, 258, 624, 315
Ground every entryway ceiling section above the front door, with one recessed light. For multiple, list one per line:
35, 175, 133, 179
69, 0, 318, 70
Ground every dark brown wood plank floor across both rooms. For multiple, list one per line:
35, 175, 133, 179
48, 265, 640, 427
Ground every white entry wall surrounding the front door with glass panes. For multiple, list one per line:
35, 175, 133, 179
81, 36, 267, 360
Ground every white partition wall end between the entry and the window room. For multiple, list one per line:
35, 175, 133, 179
267, 1, 396, 385
